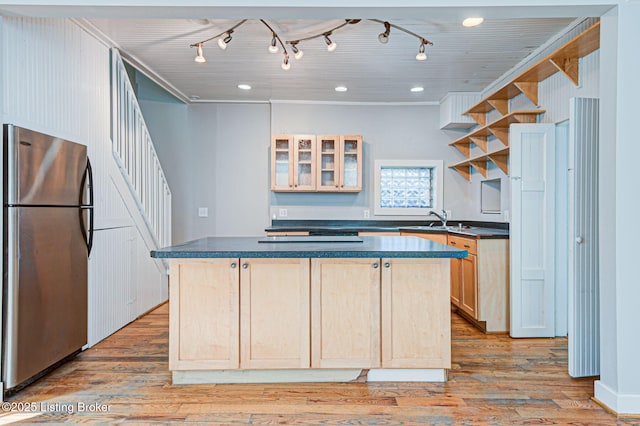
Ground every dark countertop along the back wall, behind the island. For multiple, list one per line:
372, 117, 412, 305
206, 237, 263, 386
265, 220, 509, 238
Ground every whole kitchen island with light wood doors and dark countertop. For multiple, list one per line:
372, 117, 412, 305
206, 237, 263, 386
151, 236, 467, 384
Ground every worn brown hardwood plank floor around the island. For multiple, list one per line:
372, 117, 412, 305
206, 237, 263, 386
0, 304, 640, 425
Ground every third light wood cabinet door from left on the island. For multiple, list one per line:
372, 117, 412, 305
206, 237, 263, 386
311, 259, 380, 368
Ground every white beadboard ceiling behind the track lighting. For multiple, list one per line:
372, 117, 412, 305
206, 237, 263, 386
89, 17, 574, 102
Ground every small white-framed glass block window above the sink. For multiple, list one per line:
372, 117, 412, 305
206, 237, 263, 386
375, 160, 442, 215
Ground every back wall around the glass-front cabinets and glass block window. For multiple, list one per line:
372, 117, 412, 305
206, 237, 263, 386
270, 102, 468, 220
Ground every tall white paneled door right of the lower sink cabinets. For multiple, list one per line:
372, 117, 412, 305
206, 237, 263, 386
510, 124, 555, 337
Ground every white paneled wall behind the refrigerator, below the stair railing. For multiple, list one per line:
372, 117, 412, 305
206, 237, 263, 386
0, 17, 167, 344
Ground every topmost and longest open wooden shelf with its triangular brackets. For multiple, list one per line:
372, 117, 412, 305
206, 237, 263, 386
465, 22, 600, 120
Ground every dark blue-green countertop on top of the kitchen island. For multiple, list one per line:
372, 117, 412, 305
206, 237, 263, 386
151, 237, 468, 259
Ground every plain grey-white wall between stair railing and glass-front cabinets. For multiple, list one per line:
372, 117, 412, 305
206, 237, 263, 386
139, 96, 270, 244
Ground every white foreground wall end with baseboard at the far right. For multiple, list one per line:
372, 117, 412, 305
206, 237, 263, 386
595, 1, 640, 415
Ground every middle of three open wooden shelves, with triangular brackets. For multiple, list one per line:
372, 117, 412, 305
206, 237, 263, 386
449, 109, 546, 157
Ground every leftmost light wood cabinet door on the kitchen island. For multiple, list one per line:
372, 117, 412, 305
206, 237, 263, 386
169, 259, 240, 370
